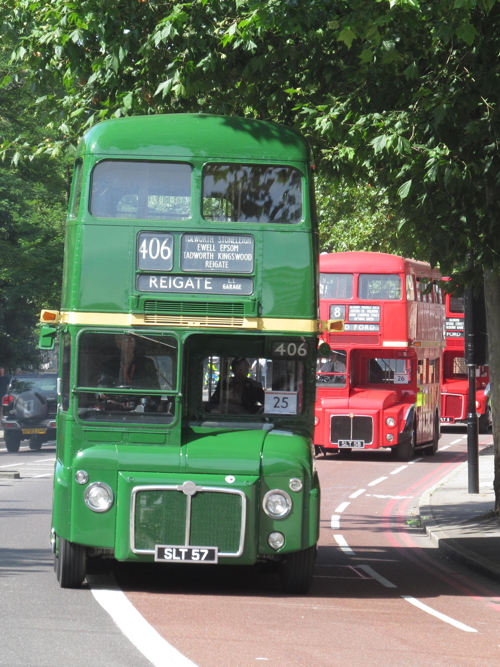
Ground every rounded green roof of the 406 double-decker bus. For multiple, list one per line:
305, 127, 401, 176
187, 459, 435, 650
77, 114, 310, 164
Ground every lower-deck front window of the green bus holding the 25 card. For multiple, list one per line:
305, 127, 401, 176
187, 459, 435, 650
202, 355, 304, 415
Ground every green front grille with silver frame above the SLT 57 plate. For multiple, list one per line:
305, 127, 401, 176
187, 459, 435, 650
131, 482, 246, 557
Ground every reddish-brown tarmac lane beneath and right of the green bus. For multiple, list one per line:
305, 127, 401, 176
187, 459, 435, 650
108, 432, 500, 667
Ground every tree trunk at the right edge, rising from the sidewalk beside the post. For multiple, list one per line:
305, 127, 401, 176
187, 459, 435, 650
484, 271, 500, 514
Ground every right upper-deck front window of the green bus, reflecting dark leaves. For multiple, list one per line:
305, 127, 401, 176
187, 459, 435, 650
203, 163, 302, 224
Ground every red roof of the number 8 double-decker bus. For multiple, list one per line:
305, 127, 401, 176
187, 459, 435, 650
319, 251, 441, 280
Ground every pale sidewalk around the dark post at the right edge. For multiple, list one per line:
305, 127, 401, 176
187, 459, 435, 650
420, 445, 500, 582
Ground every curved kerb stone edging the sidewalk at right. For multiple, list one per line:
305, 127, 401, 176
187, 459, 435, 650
419, 462, 500, 582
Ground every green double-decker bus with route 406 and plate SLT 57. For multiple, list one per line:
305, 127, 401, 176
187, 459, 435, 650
41, 114, 320, 593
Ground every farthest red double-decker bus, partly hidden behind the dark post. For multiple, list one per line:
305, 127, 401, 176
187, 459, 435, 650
441, 294, 491, 433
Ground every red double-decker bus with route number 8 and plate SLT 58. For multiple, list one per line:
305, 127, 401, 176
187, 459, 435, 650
314, 252, 445, 461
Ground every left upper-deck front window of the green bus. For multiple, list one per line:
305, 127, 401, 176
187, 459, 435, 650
90, 160, 191, 220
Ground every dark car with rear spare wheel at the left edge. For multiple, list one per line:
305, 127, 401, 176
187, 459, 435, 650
2, 373, 57, 452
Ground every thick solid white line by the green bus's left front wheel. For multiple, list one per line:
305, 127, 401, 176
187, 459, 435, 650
87, 575, 196, 667
